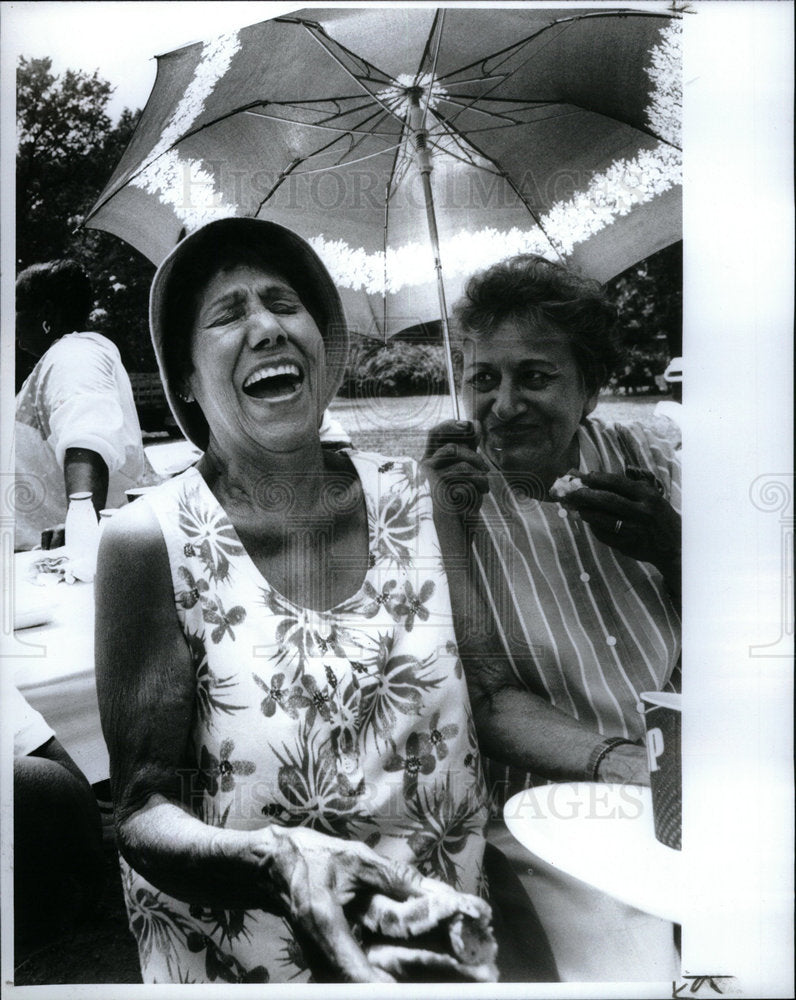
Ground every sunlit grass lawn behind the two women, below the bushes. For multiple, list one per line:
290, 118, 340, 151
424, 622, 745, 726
329, 393, 665, 459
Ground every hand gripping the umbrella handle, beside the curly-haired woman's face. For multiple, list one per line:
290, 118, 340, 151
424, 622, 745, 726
421, 420, 489, 515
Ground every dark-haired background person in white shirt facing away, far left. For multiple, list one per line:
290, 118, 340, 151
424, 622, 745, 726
14, 260, 157, 550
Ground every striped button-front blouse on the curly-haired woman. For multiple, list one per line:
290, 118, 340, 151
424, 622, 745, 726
473, 419, 681, 760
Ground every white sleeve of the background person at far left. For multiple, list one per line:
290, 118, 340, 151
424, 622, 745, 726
42, 338, 125, 473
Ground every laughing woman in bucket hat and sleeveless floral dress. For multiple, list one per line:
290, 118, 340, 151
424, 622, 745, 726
96, 219, 504, 982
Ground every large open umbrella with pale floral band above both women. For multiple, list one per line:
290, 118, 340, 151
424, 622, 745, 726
86, 7, 681, 414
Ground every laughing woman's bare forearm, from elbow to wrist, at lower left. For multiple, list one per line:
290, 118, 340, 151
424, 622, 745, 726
117, 795, 286, 913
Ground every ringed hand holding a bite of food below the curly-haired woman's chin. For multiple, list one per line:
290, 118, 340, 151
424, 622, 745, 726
550, 466, 681, 596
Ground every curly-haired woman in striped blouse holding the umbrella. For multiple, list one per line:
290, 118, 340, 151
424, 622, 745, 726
426, 255, 680, 793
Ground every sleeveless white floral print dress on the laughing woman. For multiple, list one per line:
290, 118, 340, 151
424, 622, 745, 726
122, 452, 486, 982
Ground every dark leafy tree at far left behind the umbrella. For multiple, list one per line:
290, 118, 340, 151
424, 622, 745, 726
16, 57, 156, 384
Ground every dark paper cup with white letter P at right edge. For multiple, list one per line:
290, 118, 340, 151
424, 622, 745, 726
641, 691, 683, 851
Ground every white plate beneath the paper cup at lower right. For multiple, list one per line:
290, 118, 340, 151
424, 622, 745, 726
503, 782, 684, 923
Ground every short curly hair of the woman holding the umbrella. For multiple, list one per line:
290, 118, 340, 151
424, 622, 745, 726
454, 254, 621, 395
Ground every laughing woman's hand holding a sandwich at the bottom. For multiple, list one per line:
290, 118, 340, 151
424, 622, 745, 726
249, 826, 496, 983
